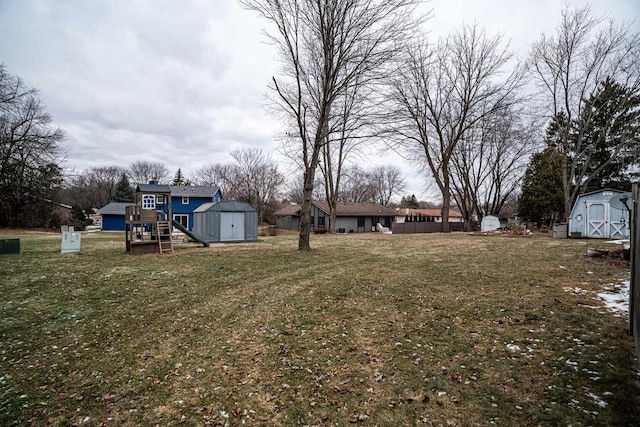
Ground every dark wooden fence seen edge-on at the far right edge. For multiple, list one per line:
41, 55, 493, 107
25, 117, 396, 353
629, 184, 640, 364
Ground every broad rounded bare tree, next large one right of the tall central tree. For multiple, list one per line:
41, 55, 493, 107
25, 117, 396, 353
390, 25, 522, 232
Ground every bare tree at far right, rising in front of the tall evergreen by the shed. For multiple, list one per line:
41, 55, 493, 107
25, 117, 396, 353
531, 6, 640, 219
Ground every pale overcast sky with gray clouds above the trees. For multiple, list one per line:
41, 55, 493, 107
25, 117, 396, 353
0, 0, 640, 198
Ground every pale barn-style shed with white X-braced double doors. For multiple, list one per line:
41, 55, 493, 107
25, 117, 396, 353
569, 188, 630, 239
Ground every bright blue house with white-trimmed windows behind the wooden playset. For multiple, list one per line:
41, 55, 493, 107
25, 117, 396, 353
98, 184, 222, 231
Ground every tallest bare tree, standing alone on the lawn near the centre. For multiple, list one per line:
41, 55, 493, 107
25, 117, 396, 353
240, 0, 421, 251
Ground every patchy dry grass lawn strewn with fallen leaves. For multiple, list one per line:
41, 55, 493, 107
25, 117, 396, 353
0, 233, 640, 426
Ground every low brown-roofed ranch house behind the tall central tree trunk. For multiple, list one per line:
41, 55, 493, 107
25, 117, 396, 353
275, 202, 396, 233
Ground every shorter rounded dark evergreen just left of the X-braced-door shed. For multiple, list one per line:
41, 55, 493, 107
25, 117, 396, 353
518, 146, 564, 227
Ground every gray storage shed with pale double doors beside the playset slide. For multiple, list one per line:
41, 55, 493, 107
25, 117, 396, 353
193, 200, 258, 243
